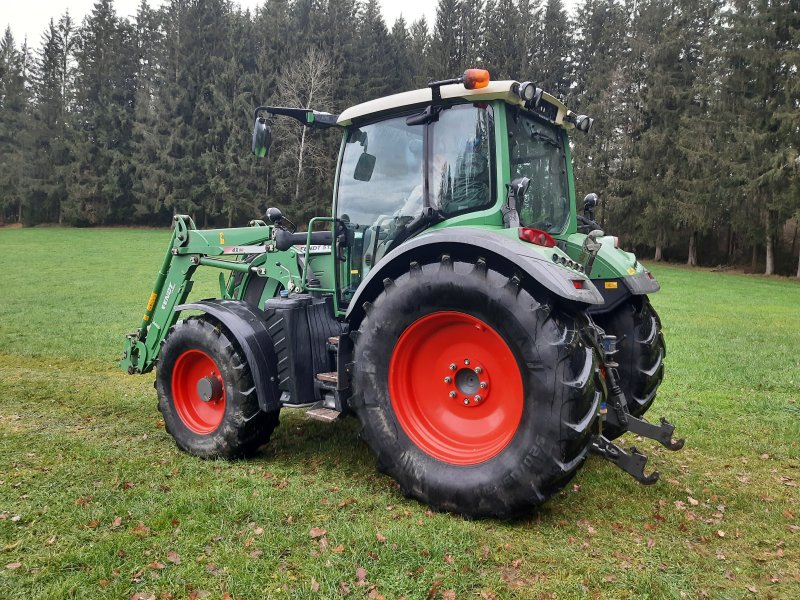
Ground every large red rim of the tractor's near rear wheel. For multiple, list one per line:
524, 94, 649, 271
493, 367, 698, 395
389, 311, 523, 465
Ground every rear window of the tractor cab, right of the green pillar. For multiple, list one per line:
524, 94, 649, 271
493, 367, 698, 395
508, 110, 570, 233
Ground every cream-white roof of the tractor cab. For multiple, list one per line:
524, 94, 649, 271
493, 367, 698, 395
337, 80, 573, 129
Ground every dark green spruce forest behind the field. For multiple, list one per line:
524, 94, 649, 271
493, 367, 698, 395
0, 0, 800, 277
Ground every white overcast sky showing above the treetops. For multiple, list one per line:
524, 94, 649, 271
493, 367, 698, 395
0, 0, 436, 48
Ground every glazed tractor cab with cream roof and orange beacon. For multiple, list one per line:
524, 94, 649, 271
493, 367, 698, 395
334, 69, 591, 307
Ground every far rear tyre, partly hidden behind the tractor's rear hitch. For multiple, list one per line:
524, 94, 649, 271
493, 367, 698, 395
594, 296, 667, 440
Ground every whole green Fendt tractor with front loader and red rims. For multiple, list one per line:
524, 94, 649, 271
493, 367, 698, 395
120, 69, 683, 517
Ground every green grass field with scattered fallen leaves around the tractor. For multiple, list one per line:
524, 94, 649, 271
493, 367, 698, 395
0, 229, 800, 599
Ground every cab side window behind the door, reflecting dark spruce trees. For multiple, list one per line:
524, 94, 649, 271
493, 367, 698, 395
428, 105, 494, 216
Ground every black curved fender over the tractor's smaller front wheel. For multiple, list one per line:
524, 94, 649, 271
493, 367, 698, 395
175, 300, 280, 412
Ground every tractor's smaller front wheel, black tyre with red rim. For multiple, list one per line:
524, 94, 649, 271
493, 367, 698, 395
156, 317, 278, 458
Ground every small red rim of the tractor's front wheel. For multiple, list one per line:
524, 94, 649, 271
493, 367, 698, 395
172, 350, 225, 434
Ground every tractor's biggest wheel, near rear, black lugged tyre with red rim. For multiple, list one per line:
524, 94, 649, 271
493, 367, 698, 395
352, 256, 599, 517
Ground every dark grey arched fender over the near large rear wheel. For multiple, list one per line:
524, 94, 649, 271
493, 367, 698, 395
346, 227, 603, 322
